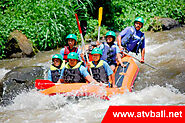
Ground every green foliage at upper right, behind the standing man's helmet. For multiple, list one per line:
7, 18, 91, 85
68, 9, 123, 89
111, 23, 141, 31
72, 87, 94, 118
106, 0, 185, 31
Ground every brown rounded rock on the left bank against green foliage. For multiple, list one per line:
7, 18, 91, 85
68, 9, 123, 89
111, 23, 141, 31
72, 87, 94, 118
6, 30, 35, 58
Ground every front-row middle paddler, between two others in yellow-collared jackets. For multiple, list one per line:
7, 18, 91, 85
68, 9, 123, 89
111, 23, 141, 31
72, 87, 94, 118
58, 52, 98, 83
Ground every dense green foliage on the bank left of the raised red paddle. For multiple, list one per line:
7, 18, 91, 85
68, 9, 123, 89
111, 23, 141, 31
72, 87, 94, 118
0, 0, 92, 58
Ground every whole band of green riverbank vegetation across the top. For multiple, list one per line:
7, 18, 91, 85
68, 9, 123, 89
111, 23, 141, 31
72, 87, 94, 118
0, 0, 185, 59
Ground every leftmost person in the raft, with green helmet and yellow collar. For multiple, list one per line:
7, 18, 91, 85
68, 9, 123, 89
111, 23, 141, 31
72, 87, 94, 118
48, 54, 65, 83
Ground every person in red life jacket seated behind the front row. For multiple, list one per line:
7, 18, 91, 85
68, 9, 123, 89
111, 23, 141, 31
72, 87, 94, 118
60, 34, 84, 62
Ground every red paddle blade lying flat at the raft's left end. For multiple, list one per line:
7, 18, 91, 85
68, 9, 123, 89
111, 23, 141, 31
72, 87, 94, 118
35, 79, 55, 89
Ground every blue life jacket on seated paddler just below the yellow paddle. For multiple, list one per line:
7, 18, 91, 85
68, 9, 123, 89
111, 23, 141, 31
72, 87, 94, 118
101, 42, 116, 64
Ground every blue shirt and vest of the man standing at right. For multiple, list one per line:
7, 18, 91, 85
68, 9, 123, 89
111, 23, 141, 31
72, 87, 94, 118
119, 26, 145, 51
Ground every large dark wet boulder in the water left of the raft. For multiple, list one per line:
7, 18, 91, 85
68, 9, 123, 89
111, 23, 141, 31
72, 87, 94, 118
0, 66, 44, 106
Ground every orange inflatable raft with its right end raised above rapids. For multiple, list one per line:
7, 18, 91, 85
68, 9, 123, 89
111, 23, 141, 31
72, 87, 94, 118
40, 56, 139, 99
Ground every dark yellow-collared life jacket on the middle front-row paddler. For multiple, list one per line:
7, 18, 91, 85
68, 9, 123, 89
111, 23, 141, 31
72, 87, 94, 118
63, 62, 86, 83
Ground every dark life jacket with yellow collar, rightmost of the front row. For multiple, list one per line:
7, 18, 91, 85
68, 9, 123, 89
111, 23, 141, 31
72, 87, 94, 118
90, 60, 108, 83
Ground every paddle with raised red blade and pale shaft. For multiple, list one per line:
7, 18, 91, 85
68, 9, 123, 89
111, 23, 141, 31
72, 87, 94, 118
75, 14, 92, 76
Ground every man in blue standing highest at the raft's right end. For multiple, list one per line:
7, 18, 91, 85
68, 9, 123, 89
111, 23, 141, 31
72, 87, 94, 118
117, 17, 145, 63
